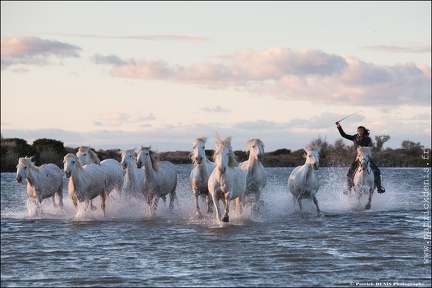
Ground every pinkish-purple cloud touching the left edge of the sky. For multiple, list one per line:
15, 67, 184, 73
1, 36, 81, 72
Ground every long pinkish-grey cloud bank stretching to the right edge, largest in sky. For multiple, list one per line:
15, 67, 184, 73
98, 47, 431, 107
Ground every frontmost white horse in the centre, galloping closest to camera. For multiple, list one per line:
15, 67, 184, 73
208, 135, 246, 222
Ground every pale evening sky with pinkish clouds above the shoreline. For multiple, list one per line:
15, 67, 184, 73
1, 1, 431, 152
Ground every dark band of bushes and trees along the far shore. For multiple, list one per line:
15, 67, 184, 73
1, 135, 430, 172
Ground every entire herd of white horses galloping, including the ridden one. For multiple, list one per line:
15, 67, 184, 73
16, 134, 375, 222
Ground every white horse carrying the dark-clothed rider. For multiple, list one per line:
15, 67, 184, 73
354, 147, 375, 210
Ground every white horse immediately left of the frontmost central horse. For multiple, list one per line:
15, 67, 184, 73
189, 137, 215, 218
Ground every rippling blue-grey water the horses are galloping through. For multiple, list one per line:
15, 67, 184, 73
1, 165, 431, 287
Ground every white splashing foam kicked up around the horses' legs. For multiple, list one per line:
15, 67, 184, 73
2, 168, 412, 226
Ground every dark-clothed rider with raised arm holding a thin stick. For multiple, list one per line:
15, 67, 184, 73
336, 122, 385, 193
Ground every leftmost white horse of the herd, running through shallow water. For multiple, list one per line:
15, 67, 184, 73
15, 157, 63, 213
